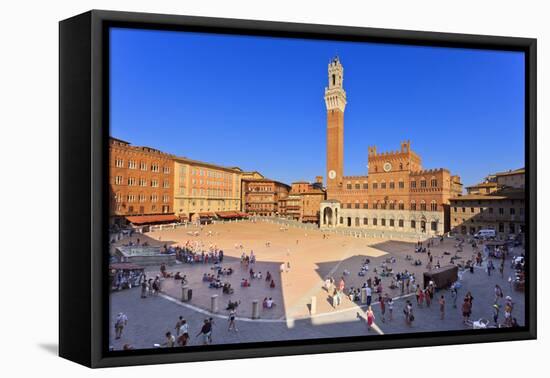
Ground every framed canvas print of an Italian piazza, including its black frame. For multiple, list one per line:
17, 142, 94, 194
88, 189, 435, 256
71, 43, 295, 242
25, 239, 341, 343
59, 11, 536, 367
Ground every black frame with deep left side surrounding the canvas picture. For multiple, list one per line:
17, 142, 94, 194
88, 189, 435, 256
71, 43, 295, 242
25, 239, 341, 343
59, 10, 537, 368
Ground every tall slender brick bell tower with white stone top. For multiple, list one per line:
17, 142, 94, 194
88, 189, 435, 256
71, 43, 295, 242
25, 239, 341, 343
325, 57, 347, 199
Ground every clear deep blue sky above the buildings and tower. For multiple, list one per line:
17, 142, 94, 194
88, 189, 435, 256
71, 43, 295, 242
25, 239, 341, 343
110, 29, 525, 189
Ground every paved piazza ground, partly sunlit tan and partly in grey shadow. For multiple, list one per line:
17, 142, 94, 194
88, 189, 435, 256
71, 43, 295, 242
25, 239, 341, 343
110, 221, 524, 349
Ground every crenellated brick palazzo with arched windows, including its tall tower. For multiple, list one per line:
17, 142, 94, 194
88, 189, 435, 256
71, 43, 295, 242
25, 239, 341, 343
320, 58, 462, 237
